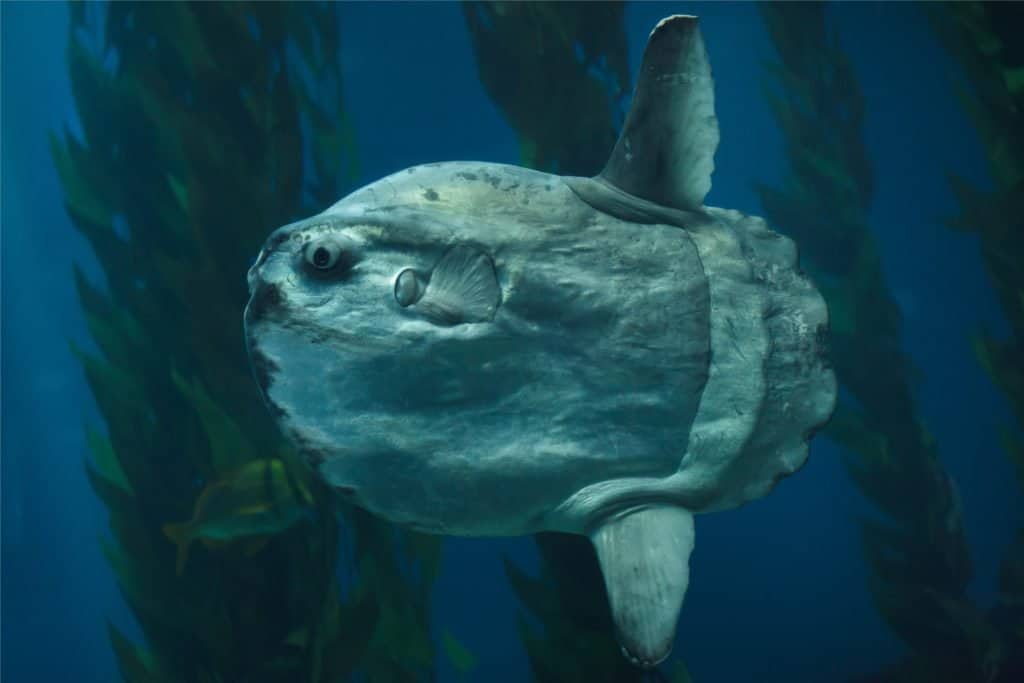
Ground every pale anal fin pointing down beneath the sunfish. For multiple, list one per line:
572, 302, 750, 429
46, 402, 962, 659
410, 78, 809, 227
590, 506, 693, 669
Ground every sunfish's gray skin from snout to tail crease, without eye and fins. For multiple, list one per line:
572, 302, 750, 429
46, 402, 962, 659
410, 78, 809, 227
247, 163, 709, 536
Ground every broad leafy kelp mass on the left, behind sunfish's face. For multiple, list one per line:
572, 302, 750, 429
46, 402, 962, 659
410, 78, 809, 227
51, 2, 439, 682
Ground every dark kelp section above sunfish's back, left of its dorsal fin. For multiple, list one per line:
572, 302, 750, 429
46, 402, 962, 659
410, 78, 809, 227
463, 2, 630, 175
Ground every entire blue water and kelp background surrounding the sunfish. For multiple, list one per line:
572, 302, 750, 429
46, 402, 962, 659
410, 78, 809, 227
0, 2, 1024, 682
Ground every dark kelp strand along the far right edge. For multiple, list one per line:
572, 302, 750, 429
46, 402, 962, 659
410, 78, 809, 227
929, 2, 1024, 680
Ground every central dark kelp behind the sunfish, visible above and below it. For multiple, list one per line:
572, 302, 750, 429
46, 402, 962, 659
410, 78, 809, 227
463, 2, 688, 683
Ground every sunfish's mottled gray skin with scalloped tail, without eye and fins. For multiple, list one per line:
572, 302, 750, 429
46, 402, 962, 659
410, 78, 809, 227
247, 162, 831, 536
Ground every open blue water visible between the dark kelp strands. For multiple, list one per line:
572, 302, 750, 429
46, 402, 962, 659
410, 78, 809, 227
0, 3, 1024, 683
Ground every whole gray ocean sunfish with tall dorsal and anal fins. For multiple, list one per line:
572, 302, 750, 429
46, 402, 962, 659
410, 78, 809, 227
245, 16, 836, 667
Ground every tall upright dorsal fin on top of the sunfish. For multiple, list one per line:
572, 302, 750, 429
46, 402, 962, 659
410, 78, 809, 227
599, 14, 719, 210
